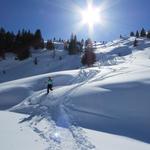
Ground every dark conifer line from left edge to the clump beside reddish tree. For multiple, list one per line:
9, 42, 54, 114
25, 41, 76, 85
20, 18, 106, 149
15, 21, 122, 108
0, 27, 83, 60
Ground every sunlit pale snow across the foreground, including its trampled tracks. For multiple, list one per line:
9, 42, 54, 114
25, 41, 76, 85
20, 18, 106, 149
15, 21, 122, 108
0, 111, 150, 150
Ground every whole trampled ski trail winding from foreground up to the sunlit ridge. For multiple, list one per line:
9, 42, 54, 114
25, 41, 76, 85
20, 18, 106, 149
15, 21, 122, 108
11, 54, 134, 150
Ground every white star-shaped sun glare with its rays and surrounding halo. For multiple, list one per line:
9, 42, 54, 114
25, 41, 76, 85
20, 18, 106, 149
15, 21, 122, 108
76, 0, 109, 37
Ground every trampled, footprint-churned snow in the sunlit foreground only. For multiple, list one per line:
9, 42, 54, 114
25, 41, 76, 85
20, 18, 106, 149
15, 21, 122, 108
20, 106, 95, 150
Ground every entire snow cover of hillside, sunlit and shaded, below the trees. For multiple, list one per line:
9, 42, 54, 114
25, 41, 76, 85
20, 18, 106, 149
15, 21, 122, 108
0, 38, 150, 150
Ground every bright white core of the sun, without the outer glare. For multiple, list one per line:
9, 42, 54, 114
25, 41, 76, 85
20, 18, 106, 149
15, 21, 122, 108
81, 3, 101, 30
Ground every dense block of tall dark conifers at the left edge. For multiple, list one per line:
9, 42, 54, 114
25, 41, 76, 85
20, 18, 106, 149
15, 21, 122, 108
0, 28, 44, 60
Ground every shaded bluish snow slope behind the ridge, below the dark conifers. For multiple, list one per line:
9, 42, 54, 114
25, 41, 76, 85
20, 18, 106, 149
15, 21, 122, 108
0, 49, 81, 83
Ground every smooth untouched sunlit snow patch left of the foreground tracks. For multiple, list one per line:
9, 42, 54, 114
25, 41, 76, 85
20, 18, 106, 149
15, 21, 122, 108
0, 111, 47, 150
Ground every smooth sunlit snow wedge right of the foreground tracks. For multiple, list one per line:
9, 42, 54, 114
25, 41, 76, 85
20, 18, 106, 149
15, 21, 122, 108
84, 129, 150, 150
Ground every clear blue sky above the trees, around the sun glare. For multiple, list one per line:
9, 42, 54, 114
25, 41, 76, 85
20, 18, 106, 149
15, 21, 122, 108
0, 0, 150, 41
